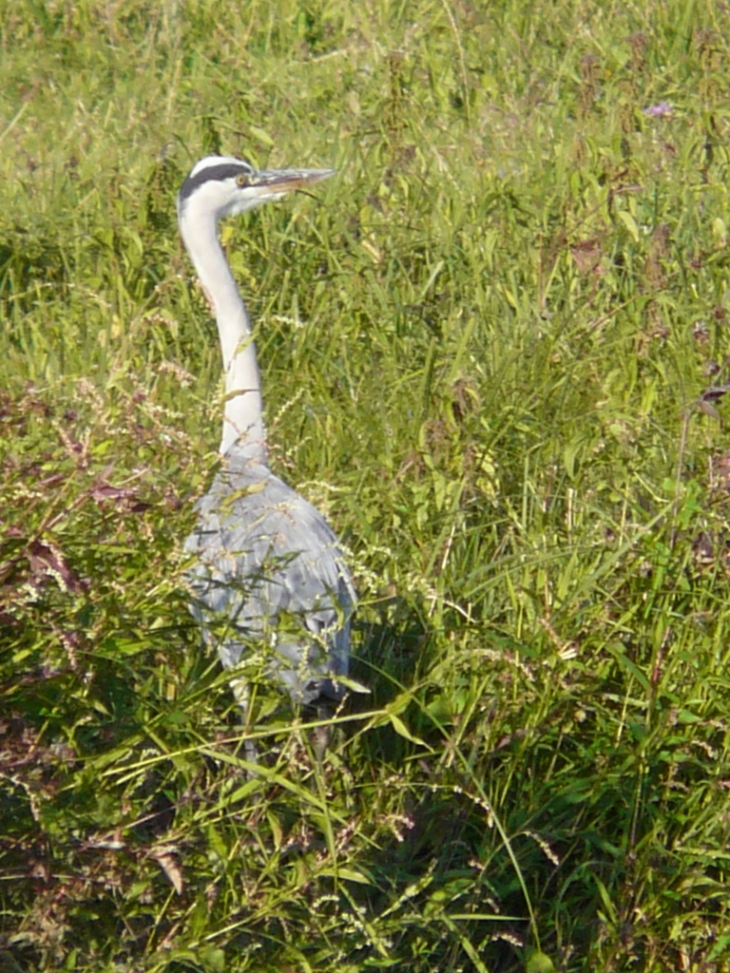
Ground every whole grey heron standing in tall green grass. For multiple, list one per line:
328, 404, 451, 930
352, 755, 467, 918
177, 156, 355, 759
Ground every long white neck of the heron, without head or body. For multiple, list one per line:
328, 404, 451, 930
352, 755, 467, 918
180, 198, 267, 463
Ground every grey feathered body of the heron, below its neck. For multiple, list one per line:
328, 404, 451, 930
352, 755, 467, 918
185, 471, 355, 702
